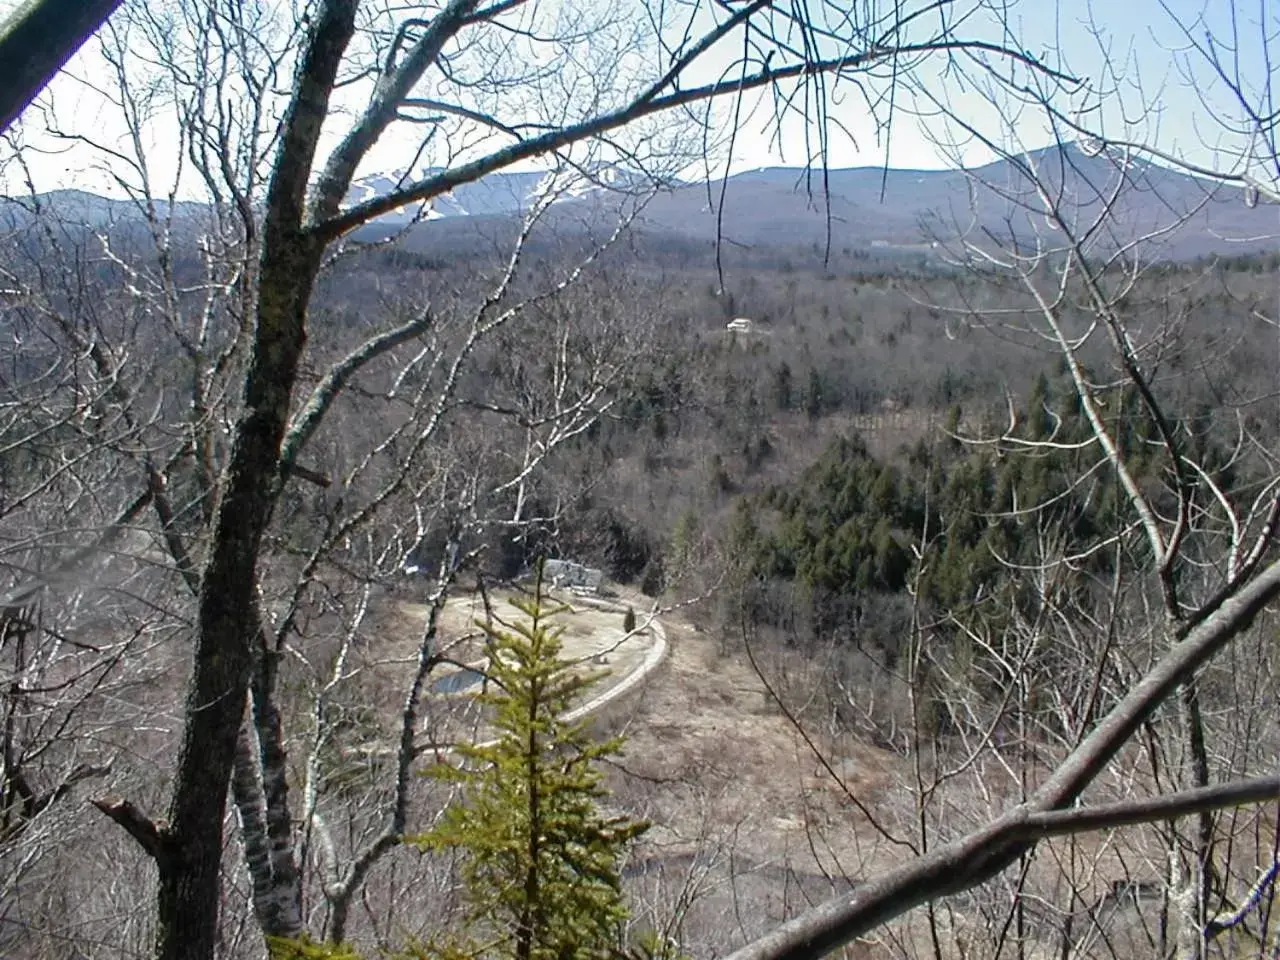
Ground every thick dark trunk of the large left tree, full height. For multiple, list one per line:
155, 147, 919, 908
156, 0, 358, 960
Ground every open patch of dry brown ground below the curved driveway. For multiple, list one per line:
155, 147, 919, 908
586, 591, 908, 950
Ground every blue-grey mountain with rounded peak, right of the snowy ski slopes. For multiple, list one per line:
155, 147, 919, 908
624, 146, 1280, 260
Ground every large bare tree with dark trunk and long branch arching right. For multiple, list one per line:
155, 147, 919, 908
5, 0, 1052, 957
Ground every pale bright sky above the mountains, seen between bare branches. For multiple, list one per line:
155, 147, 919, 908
0, 0, 1280, 195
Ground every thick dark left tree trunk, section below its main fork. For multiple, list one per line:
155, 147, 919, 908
157, 224, 320, 960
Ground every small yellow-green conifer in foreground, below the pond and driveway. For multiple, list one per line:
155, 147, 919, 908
416, 568, 648, 960
